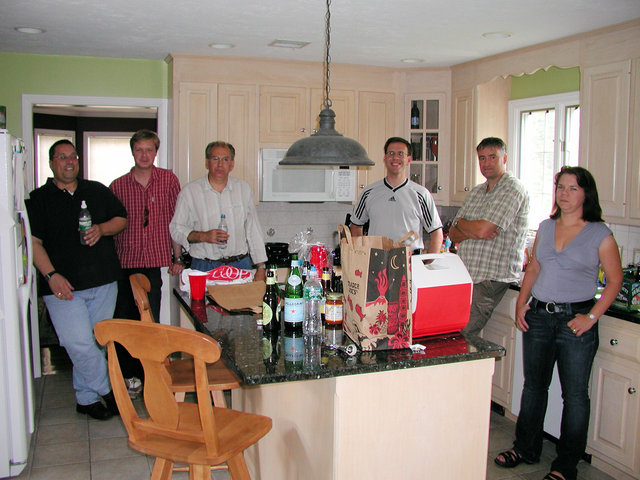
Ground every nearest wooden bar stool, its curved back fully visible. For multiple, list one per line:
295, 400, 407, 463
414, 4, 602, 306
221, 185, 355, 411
94, 320, 272, 480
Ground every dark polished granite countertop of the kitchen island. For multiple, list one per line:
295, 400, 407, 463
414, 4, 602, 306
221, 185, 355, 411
174, 289, 505, 385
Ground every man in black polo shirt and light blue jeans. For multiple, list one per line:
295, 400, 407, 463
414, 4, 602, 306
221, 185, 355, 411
27, 140, 127, 420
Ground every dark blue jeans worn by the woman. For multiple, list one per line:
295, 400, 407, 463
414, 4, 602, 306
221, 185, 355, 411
514, 307, 599, 480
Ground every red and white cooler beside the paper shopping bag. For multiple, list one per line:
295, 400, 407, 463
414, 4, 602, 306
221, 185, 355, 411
411, 253, 473, 337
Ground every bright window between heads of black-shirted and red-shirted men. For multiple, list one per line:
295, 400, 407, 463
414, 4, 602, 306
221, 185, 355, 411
84, 132, 133, 187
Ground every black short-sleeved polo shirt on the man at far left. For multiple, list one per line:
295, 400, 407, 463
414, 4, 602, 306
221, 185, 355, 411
25, 178, 127, 295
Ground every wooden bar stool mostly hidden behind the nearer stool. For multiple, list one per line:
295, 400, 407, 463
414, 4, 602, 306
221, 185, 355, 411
129, 273, 241, 408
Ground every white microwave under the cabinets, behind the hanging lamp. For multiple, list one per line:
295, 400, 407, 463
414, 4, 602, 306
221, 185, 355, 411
260, 148, 356, 202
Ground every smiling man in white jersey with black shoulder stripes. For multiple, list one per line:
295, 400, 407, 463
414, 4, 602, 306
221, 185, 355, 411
351, 137, 443, 253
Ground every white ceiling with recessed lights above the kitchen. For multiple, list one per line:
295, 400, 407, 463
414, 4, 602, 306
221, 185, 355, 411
0, 0, 640, 68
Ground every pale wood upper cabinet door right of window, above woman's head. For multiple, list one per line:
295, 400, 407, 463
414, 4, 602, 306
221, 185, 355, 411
580, 60, 638, 222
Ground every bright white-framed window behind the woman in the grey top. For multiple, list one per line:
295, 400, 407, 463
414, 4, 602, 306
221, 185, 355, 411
507, 92, 580, 230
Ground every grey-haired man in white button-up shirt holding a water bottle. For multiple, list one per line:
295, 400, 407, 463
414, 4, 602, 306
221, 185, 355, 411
169, 141, 267, 281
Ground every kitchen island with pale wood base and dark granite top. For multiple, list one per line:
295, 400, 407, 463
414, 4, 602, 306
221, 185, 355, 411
174, 290, 505, 480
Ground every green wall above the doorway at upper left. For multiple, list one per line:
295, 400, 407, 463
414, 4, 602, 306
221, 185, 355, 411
0, 52, 170, 136
